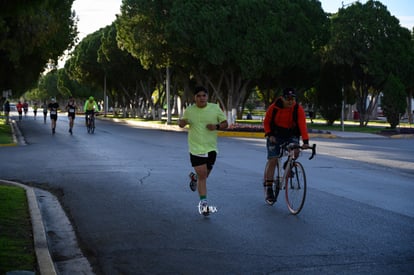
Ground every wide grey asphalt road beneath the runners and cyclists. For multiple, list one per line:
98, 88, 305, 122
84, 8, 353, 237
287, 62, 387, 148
0, 115, 414, 274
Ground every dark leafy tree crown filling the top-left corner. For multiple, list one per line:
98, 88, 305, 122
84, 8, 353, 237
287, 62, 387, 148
0, 0, 77, 96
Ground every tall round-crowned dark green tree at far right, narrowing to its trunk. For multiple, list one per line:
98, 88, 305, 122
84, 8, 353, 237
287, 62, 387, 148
327, 0, 409, 126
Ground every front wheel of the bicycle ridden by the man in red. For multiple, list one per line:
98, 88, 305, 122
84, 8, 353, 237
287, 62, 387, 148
283, 162, 306, 215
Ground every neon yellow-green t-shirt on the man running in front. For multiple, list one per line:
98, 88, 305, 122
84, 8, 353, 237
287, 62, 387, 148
183, 103, 226, 155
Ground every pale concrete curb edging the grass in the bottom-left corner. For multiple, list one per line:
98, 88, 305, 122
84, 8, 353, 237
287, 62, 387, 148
0, 180, 57, 275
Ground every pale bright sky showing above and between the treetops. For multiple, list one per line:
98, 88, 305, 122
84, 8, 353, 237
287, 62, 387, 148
72, 0, 414, 40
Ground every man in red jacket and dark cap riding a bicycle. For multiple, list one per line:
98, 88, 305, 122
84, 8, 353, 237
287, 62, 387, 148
263, 88, 309, 205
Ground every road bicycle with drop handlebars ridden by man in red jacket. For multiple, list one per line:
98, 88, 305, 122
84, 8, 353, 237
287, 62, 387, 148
273, 143, 316, 215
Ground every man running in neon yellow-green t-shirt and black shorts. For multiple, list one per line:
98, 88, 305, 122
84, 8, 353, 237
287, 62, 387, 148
178, 87, 228, 216
